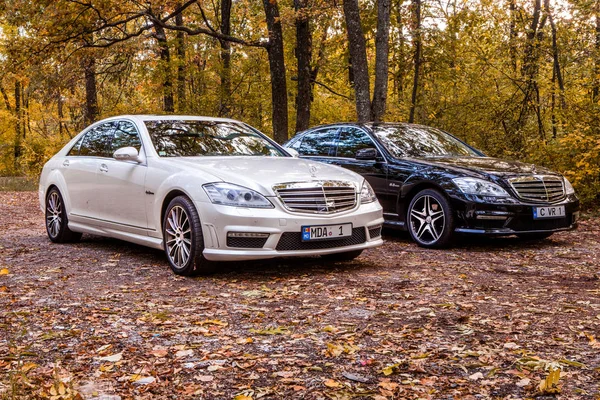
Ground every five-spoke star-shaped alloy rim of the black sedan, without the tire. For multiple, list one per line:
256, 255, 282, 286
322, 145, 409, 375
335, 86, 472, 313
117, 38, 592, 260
410, 195, 446, 244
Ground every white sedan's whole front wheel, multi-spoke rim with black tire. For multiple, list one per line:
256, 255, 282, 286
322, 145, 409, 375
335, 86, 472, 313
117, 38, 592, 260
162, 196, 215, 276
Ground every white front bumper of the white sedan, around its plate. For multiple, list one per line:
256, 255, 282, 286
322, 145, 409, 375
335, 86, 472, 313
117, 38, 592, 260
196, 198, 383, 261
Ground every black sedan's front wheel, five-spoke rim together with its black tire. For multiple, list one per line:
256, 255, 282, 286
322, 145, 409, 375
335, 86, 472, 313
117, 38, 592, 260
406, 189, 454, 247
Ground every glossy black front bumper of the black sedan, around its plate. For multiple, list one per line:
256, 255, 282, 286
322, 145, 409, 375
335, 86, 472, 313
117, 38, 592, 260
451, 195, 579, 236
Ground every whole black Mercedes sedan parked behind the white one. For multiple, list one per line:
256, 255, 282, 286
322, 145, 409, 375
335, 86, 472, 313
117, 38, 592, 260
284, 123, 579, 247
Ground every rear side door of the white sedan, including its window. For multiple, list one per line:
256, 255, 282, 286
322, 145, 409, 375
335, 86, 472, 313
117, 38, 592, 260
61, 122, 114, 222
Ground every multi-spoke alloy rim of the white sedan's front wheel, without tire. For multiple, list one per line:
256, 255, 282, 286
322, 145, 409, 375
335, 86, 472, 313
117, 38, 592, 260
165, 205, 192, 268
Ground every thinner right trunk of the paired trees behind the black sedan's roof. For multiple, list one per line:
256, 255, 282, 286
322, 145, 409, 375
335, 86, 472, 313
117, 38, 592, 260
371, 0, 391, 121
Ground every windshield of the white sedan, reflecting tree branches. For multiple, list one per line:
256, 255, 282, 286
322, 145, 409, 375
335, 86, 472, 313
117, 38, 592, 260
145, 120, 286, 157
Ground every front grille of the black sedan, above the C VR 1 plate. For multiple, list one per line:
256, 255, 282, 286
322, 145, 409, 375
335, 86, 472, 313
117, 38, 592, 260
509, 175, 565, 203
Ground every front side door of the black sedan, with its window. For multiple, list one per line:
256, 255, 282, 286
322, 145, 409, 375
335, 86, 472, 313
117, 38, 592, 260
333, 126, 396, 212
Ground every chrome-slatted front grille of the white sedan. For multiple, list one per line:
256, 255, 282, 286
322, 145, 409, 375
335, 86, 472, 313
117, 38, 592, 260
273, 181, 356, 214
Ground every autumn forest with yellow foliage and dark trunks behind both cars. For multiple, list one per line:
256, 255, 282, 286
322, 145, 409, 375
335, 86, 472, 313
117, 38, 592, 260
0, 0, 600, 207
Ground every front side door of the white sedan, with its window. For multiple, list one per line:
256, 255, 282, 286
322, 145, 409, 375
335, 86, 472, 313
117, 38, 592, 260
97, 120, 148, 233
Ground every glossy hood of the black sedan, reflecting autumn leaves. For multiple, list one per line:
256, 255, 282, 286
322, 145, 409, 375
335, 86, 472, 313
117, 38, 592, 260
420, 157, 558, 177
